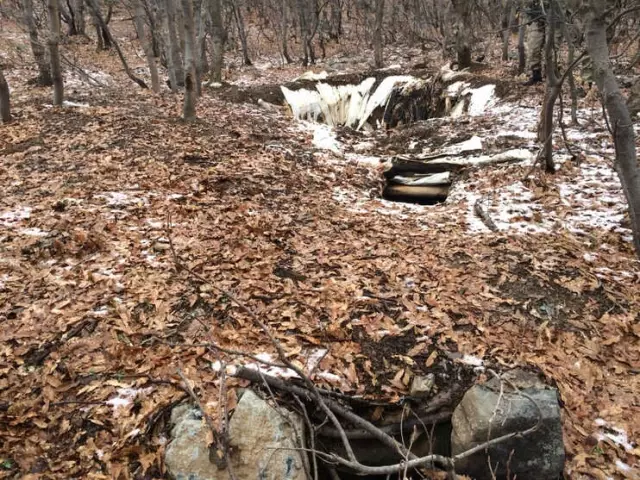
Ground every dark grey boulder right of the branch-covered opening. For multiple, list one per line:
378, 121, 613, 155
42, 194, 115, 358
451, 370, 564, 480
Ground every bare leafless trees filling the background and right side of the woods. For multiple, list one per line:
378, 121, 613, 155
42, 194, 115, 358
0, 0, 640, 254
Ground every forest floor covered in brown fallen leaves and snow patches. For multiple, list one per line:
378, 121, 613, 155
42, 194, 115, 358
0, 15, 640, 479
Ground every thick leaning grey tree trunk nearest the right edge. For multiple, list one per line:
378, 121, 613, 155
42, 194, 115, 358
586, 0, 640, 256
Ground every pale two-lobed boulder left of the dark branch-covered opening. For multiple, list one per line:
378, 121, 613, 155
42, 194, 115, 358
165, 390, 307, 480
